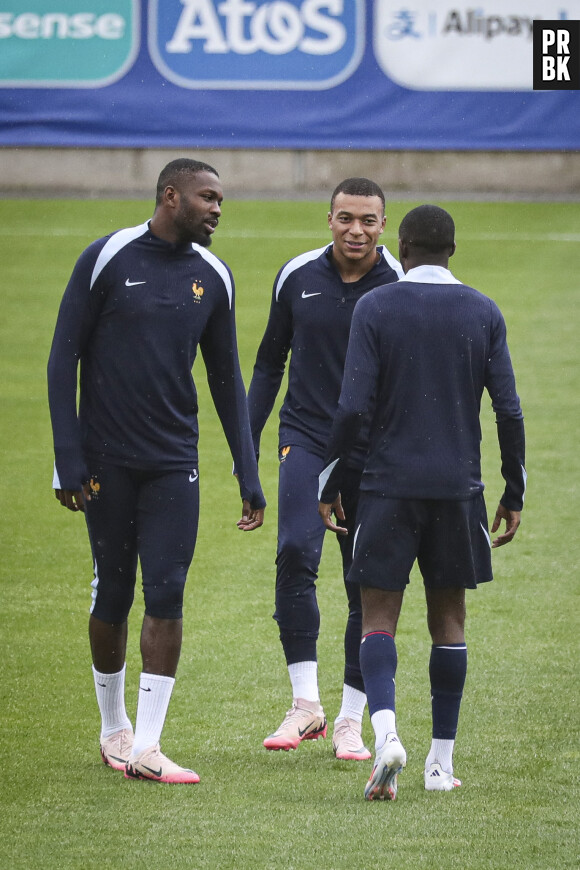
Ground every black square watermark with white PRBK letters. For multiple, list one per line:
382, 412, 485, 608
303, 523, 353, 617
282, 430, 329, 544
533, 19, 580, 91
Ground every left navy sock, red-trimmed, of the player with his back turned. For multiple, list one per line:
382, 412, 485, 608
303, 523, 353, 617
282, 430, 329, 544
360, 631, 397, 716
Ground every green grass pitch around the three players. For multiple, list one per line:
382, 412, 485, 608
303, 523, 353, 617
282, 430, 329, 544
0, 199, 580, 870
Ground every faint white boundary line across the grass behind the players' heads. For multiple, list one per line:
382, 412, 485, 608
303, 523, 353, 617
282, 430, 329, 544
0, 226, 580, 244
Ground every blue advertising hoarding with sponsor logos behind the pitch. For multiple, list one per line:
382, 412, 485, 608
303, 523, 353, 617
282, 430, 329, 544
0, 0, 580, 150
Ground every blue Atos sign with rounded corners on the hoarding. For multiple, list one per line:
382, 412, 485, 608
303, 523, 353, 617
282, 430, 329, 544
148, 0, 365, 90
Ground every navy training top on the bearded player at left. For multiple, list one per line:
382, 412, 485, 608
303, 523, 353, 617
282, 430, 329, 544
48, 222, 265, 508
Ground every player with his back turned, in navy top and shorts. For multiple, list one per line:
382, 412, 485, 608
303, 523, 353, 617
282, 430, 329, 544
319, 205, 526, 800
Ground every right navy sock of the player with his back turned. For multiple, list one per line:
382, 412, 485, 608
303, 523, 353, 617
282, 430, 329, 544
429, 643, 467, 740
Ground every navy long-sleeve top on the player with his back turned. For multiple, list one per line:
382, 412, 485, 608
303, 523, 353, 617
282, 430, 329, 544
320, 266, 526, 510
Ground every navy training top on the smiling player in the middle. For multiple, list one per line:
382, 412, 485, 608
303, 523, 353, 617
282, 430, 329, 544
248, 245, 403, 466
